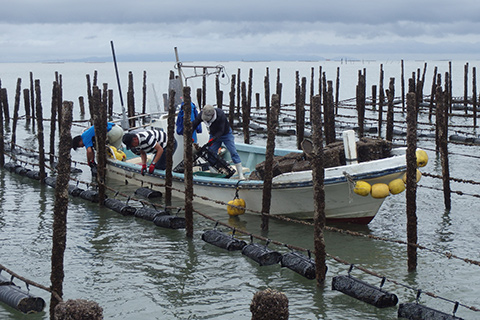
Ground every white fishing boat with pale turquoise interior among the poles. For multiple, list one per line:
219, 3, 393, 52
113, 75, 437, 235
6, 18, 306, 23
107, 115, 406, 224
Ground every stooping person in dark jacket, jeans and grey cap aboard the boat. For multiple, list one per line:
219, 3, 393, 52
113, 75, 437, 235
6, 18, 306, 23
192, 104, 244, 180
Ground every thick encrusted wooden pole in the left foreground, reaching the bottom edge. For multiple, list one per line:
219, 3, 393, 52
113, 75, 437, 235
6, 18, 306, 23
50, 101, 73, 319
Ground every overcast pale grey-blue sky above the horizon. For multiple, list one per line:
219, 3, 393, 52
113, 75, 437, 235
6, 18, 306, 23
0, 0, 480, 62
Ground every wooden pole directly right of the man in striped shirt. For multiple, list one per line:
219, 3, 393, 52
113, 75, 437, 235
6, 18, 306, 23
165, 90, 176, 206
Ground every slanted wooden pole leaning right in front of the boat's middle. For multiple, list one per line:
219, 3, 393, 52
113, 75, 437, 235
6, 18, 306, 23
261, 94, 280, 231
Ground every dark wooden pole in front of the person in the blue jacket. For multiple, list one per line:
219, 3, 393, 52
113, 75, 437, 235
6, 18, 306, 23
183, 87, 193, 238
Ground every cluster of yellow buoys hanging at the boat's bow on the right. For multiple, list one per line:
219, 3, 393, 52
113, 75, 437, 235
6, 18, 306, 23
353, 149, 428, 199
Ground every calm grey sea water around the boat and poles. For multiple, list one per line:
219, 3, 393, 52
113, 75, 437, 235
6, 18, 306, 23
0, 61, 480, 319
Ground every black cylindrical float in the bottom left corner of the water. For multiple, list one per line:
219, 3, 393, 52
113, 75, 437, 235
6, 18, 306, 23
0, 275, 45, 313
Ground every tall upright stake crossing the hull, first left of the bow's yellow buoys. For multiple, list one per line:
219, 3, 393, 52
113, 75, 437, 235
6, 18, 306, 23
310, 95, 327, 286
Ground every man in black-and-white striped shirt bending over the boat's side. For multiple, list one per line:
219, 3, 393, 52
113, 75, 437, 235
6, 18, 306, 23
123, 128, 177, 174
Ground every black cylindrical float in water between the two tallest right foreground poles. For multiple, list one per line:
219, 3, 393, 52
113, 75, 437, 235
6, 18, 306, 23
332, 275, 398, 308
